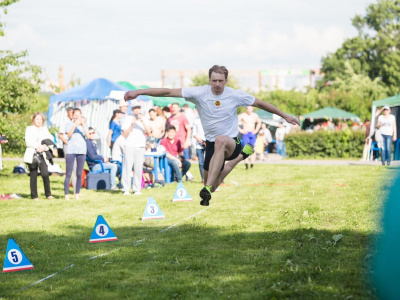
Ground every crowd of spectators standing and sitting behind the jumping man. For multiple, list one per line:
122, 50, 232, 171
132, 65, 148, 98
5, 100, 397, 199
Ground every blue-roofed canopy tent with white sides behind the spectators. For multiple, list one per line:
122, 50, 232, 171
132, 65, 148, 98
47, 78, 148, 154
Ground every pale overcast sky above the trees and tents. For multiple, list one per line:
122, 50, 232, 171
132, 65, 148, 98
0, 0, 375, 82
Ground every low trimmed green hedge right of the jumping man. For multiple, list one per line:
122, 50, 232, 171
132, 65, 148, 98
285, 129, 365, 158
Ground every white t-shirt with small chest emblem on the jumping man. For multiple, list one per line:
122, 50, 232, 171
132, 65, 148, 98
182, 85, 255, 142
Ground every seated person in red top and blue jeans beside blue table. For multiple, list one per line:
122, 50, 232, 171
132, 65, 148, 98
161, 126, 191, 182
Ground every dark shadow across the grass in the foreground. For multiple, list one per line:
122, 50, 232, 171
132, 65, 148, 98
0, 225, 374, 299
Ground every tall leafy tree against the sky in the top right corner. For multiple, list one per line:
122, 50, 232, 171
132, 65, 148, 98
322, 0, 400, 95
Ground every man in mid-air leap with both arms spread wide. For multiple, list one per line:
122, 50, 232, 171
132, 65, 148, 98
125, 65, 299, 206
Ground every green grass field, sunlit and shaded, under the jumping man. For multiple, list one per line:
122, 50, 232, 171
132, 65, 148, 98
0, 161, 394, 299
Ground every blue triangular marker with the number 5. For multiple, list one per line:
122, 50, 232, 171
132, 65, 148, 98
3, 239, 34, 273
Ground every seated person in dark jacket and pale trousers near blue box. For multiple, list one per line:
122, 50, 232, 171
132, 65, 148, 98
86, 127, 118, 190
